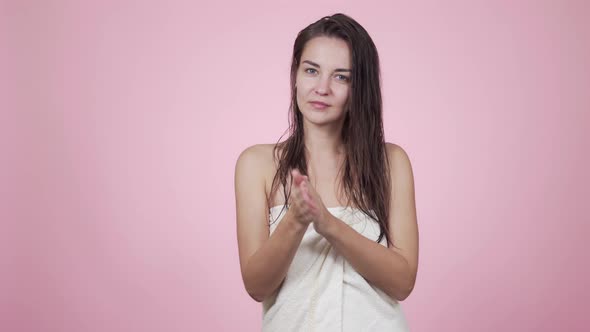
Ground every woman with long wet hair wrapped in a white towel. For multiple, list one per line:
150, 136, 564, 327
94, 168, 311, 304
235, 14, 418, 331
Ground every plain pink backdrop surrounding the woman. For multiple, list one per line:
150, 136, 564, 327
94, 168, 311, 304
0, 0, 590, 332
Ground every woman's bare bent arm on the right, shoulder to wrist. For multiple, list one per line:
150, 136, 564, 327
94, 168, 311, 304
312, 143, 418, 301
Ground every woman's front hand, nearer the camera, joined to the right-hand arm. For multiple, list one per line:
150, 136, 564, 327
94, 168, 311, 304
292, 170, 334, 235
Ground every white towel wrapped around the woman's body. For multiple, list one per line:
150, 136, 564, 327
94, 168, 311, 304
262, 206, 409, 332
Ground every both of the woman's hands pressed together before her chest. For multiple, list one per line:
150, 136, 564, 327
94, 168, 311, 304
290, 169, 334, 235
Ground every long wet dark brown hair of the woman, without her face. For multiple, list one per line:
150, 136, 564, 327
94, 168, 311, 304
268, 14, 393, 244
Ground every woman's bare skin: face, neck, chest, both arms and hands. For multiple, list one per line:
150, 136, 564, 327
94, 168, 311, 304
235, 37, 418, 302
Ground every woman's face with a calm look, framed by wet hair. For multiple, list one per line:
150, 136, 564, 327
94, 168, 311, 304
296, 37, 351, 125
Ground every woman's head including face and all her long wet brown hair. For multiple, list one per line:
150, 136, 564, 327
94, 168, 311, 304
268, 14, 391, 243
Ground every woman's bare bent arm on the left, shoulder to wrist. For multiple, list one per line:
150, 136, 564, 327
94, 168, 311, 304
235, 145, 309, 302
